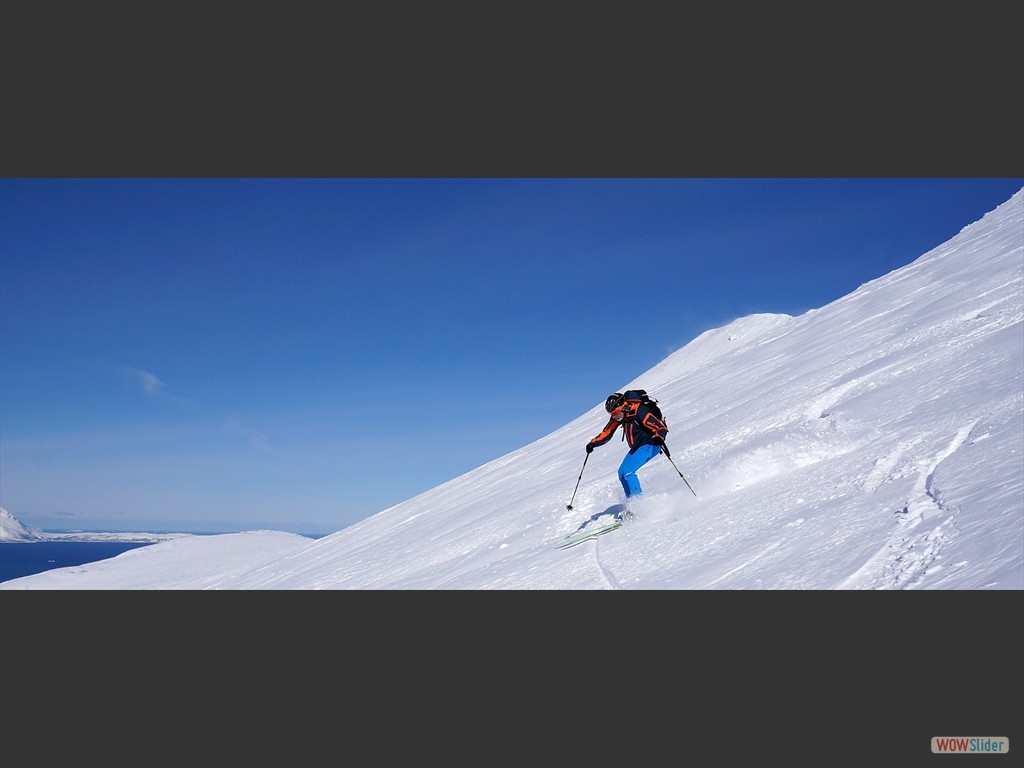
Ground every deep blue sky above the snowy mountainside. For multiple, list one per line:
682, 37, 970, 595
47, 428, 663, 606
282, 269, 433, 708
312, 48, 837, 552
0, 178, 1024, 534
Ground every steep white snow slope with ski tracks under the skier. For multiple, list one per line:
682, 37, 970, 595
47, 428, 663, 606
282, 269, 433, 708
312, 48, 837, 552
2, 190, 1024, 590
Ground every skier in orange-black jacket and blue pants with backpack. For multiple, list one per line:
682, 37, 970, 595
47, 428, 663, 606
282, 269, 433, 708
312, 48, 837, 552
587, 389, 667, 517
